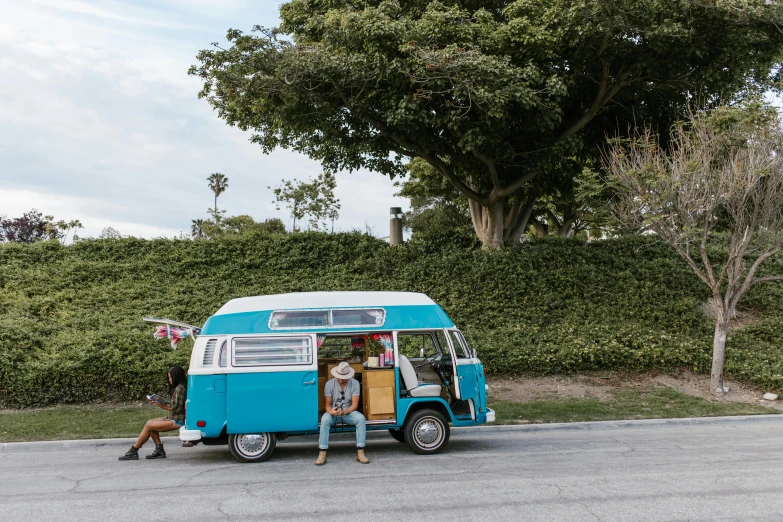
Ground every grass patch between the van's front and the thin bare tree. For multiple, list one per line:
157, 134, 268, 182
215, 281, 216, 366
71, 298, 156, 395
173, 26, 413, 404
489, 386, 778, 424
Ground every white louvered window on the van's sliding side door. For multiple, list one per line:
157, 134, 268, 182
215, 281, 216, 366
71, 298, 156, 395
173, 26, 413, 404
232, 336, 313, 366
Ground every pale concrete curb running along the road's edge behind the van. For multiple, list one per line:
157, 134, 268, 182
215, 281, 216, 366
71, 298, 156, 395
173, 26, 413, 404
0, 414, 783, 454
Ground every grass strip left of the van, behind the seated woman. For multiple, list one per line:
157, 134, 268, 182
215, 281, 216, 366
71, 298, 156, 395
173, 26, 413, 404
0, 405, 170, 442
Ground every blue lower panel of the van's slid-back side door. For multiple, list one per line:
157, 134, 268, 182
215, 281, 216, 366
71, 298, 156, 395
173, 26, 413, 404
226, 369, 318, 434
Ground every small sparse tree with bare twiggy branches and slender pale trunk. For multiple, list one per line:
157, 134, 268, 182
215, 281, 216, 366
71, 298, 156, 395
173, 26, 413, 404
604, 106, 783, 394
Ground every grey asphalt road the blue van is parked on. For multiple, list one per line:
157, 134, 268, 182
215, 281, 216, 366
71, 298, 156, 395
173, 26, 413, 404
0, 416, 783, 522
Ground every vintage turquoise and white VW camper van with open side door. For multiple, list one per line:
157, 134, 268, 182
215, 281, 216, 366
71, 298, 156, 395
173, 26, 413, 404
180, 292, 495, 462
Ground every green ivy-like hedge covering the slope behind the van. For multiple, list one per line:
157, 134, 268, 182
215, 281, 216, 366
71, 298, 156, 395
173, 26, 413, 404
0, 233, 783, 406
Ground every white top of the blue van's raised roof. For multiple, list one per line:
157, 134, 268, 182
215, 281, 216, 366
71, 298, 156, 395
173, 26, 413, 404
215, 292, 435, 315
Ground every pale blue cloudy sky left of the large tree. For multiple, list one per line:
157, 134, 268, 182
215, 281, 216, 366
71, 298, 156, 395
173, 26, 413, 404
0, 0, 409, 237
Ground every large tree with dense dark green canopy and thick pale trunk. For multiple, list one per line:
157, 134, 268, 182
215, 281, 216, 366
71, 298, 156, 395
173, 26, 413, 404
190, 0, 783, 247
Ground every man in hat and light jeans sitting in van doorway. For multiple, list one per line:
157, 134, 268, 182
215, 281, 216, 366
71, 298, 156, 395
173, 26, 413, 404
315, 362, 370, 466
